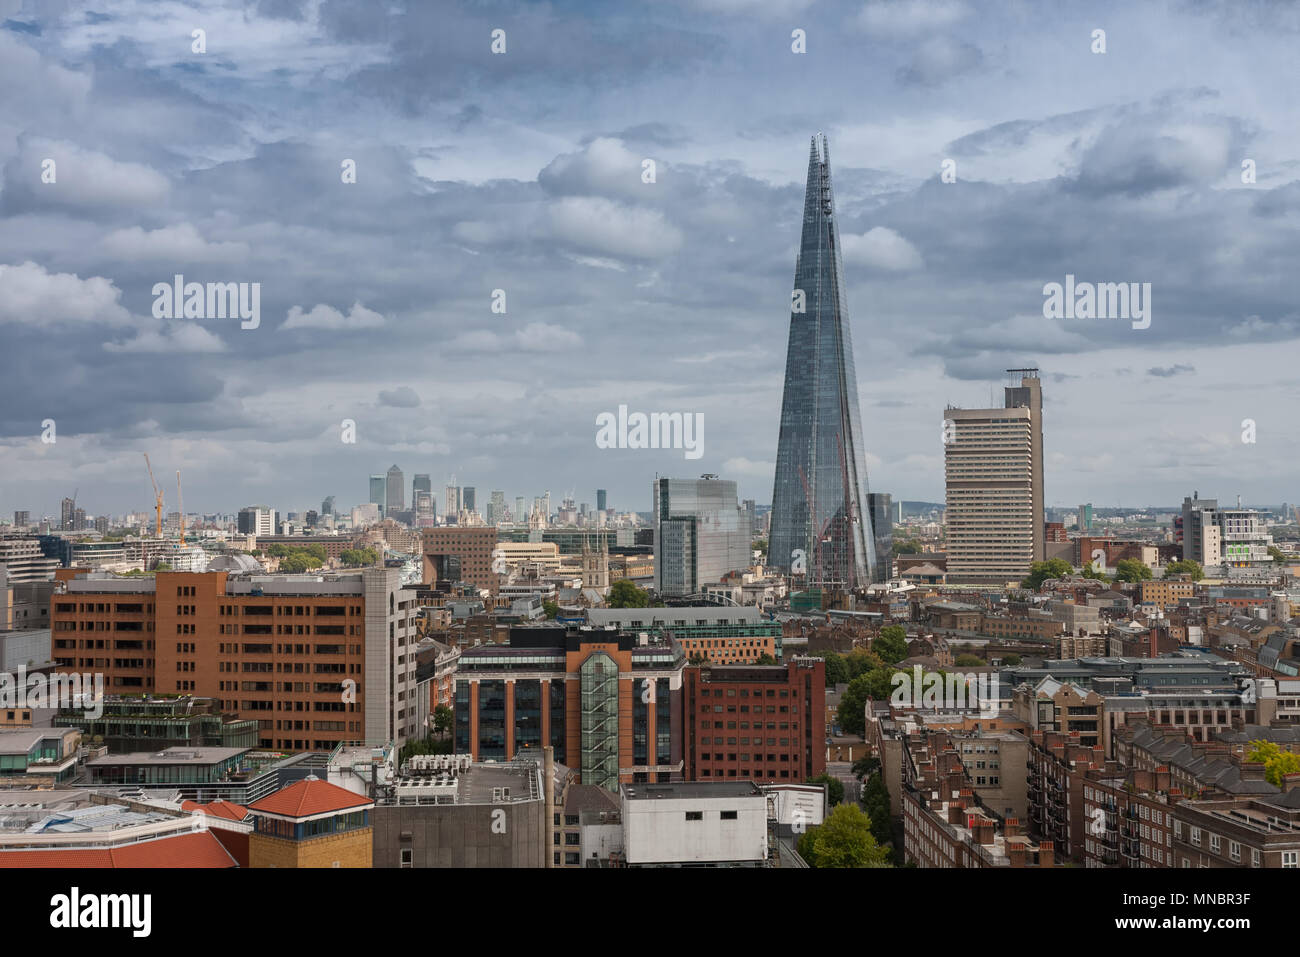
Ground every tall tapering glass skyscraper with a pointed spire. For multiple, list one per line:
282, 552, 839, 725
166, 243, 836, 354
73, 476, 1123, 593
768, 137, 876, 590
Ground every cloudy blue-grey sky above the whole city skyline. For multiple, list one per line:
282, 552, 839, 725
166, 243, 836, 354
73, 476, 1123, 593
0, 0, 1300, 514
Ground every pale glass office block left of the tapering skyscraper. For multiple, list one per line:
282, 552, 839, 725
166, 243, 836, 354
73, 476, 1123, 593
651, 475, 750, 597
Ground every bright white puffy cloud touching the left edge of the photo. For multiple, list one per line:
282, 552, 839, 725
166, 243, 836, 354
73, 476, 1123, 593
0, 261, 131, 325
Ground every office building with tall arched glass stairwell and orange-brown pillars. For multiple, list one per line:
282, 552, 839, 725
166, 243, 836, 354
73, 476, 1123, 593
454, 625, 686, 791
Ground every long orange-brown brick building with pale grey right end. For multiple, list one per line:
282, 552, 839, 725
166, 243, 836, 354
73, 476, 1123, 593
51, 568, 425, 750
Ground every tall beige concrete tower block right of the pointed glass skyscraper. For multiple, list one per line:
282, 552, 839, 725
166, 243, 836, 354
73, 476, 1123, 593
944, 369, 1047, 585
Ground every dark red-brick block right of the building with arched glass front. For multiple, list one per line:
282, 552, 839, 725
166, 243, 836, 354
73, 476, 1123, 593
681, 658, 826, 781
